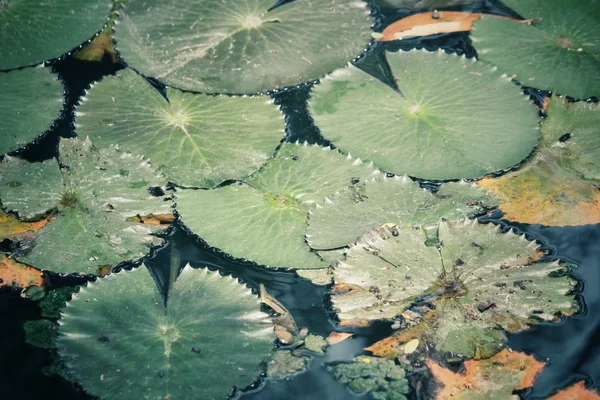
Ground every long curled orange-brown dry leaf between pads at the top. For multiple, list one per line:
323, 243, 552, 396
377, 11, 532, 42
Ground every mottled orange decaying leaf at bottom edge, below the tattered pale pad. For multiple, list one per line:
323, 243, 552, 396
425, 349, 545, 400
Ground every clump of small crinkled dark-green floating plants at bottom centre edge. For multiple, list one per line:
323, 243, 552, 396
327, 356, 410, 400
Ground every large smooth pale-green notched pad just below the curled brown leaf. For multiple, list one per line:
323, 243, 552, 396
308, 50, 540, 180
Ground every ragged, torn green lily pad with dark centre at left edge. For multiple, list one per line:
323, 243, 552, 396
0, 139, 172, 274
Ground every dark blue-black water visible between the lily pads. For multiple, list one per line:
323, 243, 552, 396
0, 2, 600, 400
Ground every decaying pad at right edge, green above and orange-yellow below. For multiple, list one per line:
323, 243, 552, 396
478, 98, 600, 226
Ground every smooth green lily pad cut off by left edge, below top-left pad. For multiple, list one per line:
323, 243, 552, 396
0, 68, 64, 154
